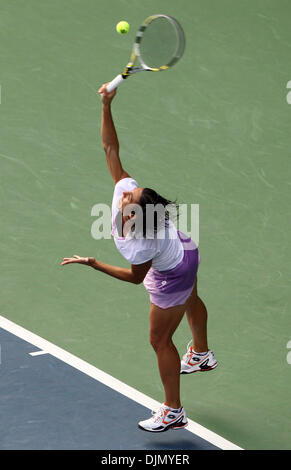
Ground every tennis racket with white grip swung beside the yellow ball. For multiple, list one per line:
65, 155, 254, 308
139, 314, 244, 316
106, 15, 185, 93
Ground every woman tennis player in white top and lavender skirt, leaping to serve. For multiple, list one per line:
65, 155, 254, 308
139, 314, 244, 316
62, 84, 217, 432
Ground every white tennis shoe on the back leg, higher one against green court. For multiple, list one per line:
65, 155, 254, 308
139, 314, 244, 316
181, 341, 218, 374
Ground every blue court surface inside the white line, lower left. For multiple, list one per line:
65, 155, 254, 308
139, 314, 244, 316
0, 317, 240, 450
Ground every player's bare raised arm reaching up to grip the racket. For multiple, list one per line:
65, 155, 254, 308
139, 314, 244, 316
98, 84, 129, 184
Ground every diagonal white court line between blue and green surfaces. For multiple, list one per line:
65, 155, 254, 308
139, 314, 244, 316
0, 315, 242, 450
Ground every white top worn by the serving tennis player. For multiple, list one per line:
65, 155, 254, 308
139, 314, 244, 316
111, 178, 184, 271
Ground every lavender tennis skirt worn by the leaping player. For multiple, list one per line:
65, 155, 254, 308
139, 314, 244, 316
143, 231, 200, 308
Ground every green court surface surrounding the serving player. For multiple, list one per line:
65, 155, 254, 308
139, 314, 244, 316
0, 0, 291, 449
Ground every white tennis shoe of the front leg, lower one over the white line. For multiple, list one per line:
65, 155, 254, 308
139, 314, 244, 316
138, 404, 188, 432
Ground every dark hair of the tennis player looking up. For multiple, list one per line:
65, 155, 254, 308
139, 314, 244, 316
138, 188, 178, 238
